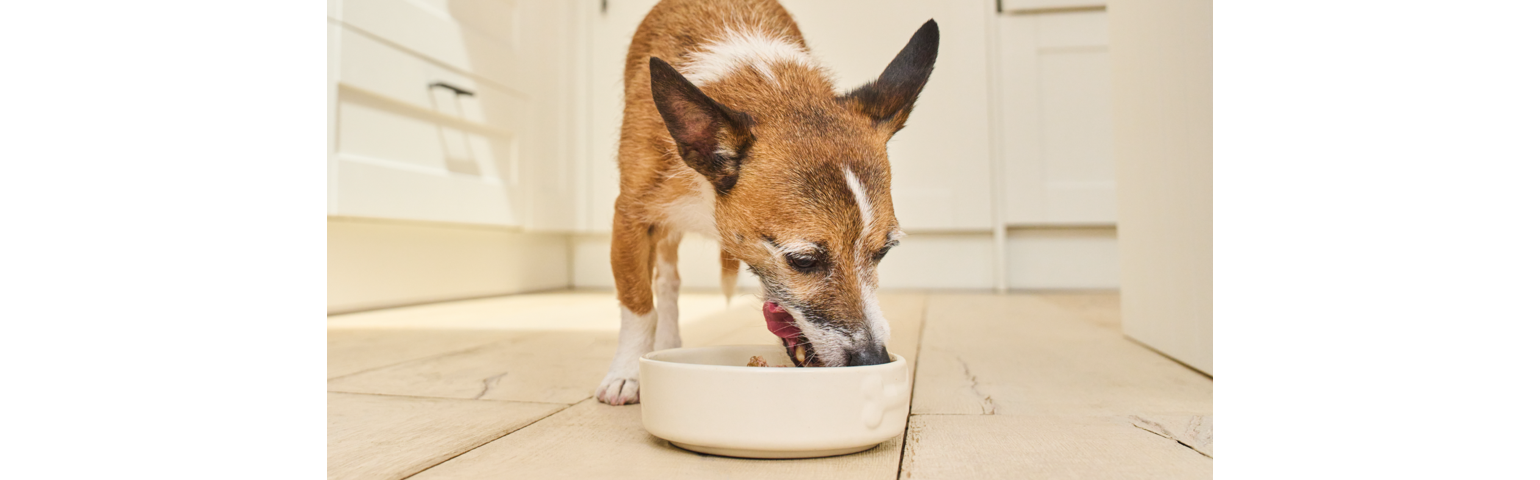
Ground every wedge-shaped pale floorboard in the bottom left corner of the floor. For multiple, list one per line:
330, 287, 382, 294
326, 392, 565, 478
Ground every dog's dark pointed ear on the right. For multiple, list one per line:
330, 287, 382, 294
839, 20, 941, 134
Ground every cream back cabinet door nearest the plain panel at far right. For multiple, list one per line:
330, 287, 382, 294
998, 9, 1117, 225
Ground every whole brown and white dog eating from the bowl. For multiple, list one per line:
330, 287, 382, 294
594, 0, 939, 405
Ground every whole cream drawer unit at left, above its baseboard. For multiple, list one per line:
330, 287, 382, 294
326, 0, 576, 229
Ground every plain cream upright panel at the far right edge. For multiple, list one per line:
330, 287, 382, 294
1109, 0, 1214, 375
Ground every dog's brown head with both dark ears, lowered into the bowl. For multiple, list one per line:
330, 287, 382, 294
651, 20, 939, 366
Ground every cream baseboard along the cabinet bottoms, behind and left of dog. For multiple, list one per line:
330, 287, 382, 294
326, 217, 1118, 314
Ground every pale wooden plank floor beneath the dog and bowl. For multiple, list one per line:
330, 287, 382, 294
326, 291, 1214, 480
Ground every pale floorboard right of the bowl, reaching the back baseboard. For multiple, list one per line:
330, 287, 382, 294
912, 294, 1214, 415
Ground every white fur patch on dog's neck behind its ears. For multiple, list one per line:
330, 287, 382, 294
679, 28, 813, 86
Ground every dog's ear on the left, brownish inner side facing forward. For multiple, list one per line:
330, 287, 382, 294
650, 57, 755, 195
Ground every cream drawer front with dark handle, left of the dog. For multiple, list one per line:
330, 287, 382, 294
328, 29, 527, 226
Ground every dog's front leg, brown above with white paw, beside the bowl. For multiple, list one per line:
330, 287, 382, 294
593, 221, 658, 405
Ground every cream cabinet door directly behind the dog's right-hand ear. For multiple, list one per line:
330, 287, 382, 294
781, 0, 993, 231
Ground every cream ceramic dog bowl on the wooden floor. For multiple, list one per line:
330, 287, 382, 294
641, 345, 910, 458
